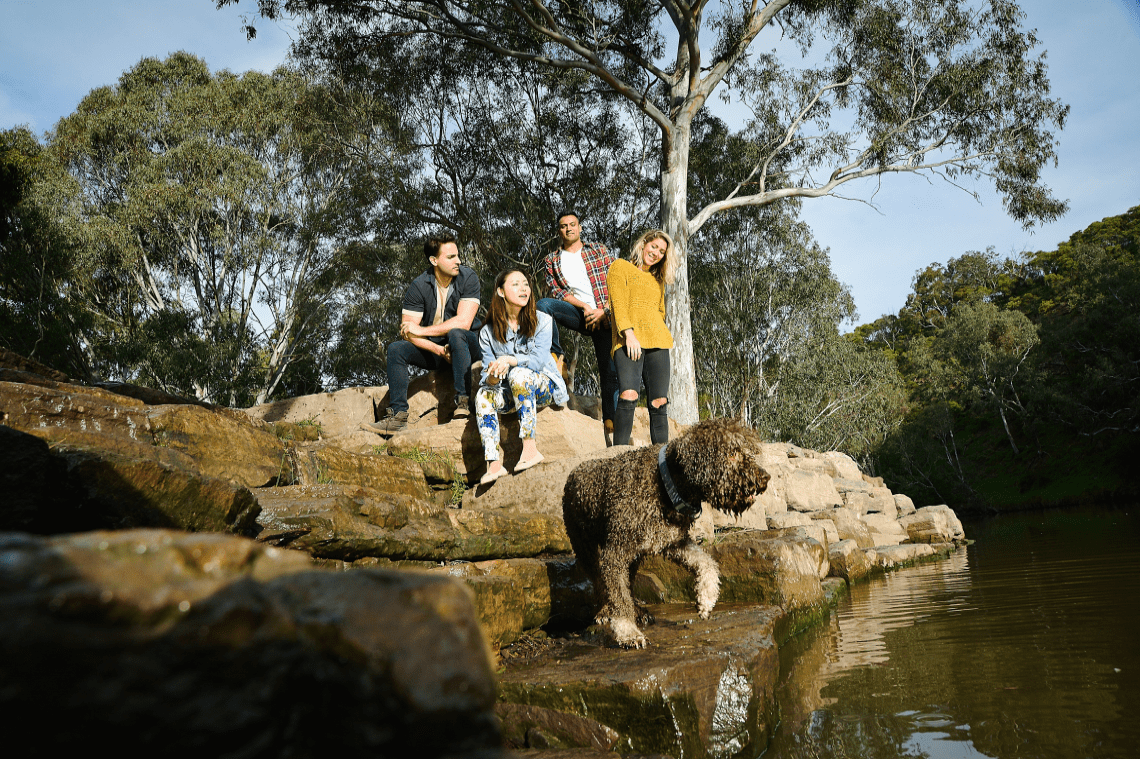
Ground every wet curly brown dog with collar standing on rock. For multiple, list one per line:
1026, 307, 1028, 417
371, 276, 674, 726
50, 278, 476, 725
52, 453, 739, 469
562, 419, 768, 648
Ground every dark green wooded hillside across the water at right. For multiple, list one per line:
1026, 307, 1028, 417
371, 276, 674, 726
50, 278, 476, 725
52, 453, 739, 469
853, 206, 1140, 508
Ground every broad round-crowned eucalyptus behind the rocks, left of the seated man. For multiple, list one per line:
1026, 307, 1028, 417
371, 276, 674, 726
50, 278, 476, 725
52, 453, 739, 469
50, 52, 399, 405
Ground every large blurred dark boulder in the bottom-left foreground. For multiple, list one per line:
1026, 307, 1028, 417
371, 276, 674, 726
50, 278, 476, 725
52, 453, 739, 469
0, 531, 500, 759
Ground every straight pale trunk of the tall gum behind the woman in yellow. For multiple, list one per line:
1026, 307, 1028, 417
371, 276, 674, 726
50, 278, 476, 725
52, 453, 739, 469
661, 121, 699, 424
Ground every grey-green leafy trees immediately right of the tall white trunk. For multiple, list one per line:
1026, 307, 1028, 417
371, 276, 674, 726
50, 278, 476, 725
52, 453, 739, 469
691, 200, 903, 462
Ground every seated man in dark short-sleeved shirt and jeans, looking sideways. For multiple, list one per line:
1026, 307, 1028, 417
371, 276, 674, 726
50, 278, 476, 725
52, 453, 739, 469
361, 232, 482, 435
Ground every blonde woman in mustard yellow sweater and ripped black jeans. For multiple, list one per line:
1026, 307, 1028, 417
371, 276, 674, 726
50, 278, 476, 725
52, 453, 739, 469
606, 229, 677, 446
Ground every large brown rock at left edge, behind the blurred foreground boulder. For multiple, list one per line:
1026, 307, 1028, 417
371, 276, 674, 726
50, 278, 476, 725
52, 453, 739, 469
0, 369, 290, 534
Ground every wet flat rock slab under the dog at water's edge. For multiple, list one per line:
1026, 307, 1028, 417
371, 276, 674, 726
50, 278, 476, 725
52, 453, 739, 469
499, 604, 783, 759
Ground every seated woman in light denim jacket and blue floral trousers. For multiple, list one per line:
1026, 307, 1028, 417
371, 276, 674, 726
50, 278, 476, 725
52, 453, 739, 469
475, 269, 570, 484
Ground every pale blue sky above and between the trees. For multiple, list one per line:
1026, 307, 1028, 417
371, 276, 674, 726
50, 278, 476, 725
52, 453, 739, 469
0, 0, 1140, 321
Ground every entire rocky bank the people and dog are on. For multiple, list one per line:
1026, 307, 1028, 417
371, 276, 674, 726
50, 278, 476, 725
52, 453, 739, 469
0, 352, 964, 759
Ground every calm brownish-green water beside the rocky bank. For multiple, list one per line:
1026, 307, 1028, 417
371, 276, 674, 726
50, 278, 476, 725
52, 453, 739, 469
764, 508, 1140, 759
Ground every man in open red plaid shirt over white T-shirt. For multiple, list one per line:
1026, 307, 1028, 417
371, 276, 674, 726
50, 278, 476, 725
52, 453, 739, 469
537, 211, 618, 446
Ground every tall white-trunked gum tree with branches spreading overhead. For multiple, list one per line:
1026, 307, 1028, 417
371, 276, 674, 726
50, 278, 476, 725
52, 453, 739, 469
229, 0, 1067, 423
